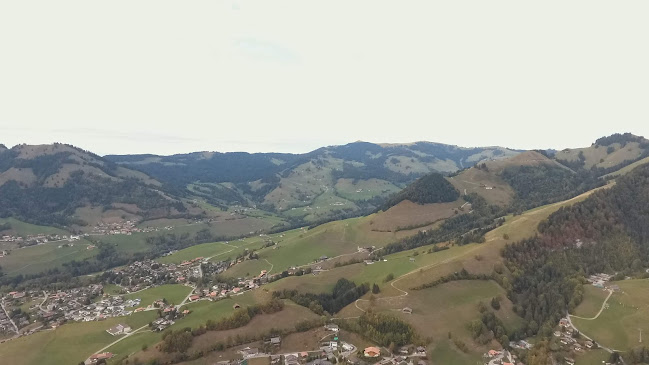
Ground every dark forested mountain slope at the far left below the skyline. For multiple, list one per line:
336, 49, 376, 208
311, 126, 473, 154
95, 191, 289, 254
0, 144, 192, 225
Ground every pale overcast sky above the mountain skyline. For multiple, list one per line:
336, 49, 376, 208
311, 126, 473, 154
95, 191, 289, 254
0, 0, 649, 154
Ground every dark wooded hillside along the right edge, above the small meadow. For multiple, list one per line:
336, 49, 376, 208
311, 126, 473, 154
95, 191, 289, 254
503, 165, 649, 352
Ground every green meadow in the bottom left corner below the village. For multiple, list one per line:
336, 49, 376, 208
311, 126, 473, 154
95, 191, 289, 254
0, 311, 157, 365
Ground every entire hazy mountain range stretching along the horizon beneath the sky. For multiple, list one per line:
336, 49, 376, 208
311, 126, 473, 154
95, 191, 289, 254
0, 134, 649, 227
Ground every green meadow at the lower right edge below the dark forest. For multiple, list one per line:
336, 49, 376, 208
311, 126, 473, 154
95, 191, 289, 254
572, 279, 649, 351
